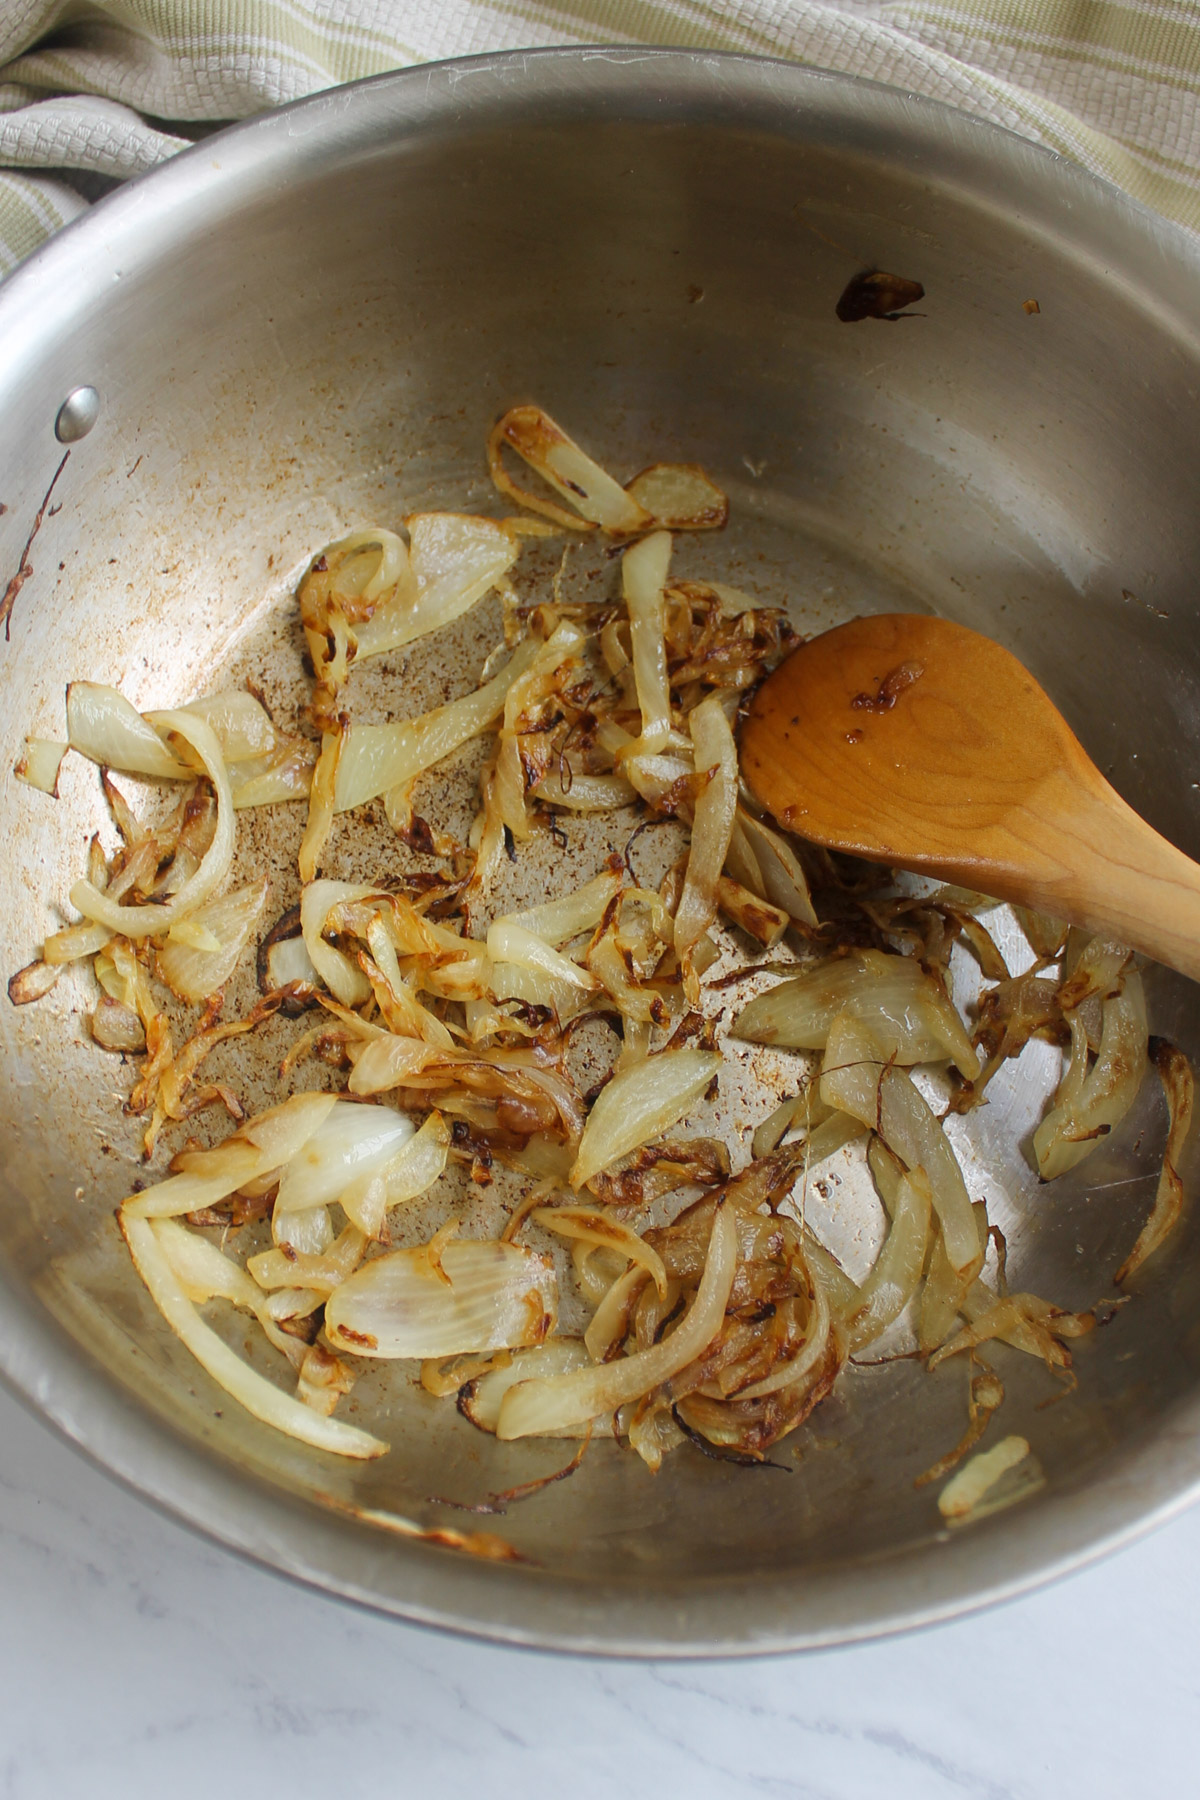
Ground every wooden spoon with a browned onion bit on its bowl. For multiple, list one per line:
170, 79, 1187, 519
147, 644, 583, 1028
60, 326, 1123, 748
741, 612, 1200, 979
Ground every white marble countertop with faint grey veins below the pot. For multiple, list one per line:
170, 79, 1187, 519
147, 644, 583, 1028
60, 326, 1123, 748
0, 1391, 1200, 1800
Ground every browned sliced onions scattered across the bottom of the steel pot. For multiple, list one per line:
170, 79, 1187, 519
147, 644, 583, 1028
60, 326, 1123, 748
9, 405, 1165, 1468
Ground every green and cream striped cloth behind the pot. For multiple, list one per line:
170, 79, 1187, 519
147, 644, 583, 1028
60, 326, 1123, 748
0, 0, 1200, 274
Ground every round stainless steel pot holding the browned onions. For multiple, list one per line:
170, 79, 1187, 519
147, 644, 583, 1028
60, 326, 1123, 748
0, 50, 1200, 1654
